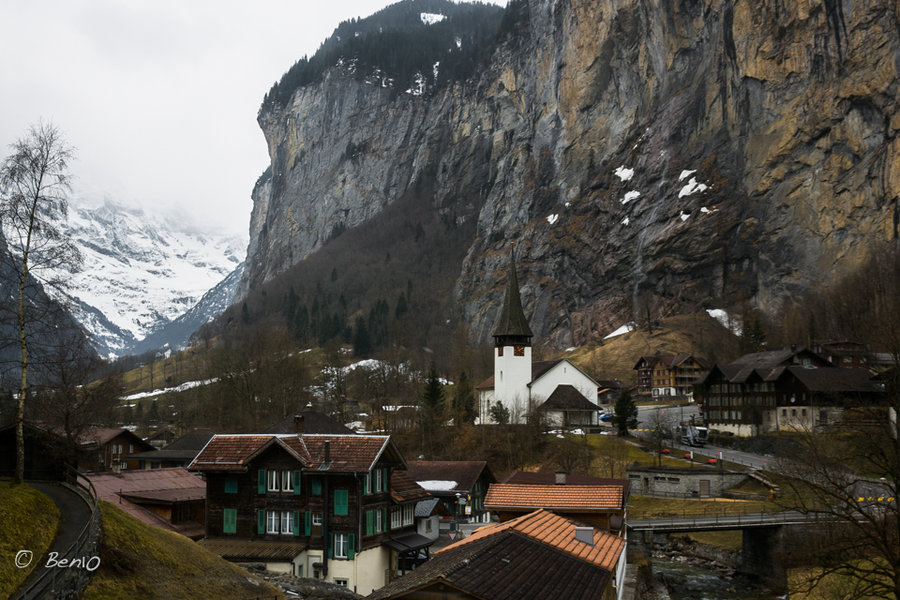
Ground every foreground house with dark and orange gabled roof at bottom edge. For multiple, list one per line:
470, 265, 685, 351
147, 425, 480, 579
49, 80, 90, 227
368, 510, 626, 600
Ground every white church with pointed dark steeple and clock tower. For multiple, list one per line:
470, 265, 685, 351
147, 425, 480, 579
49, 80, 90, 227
476, 254, 600, 428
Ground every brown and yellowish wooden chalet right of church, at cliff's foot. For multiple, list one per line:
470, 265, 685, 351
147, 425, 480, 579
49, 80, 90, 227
633, 352, 707, 401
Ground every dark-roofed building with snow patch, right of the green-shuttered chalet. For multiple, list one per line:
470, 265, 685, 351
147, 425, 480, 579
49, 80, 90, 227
407, 460, 497, 523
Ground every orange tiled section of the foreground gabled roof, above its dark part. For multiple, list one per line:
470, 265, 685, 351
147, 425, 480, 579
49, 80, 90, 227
435, 509, 625, 572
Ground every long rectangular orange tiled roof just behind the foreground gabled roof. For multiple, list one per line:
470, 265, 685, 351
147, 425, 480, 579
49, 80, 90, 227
484, 483, 625, 512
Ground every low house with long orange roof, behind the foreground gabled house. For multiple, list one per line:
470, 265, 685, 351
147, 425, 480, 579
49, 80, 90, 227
484, 473, 631, 536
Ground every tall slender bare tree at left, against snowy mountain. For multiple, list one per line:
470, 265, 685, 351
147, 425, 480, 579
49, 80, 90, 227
0, 123, 81, 481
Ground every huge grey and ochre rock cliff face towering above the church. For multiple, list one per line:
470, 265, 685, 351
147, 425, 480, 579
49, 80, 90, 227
241, 0, 900, 347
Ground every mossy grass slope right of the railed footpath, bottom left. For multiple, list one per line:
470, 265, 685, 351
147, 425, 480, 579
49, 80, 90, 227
82, 502, 283, 600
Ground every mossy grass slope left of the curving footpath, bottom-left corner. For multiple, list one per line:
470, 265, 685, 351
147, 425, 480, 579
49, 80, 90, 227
0, 482, 59, 598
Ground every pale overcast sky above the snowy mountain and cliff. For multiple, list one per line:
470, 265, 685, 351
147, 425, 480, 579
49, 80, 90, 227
0, 0, 506, 236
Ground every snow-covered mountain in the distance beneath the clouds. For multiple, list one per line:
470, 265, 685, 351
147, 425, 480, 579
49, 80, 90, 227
65, 196, 247, 356
